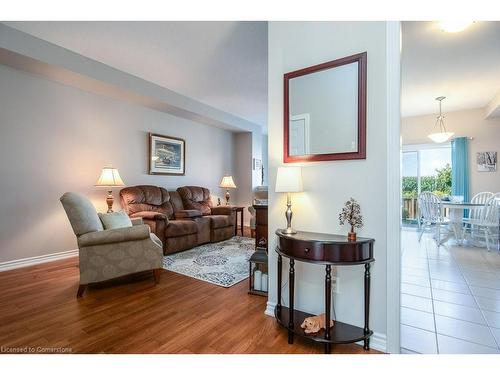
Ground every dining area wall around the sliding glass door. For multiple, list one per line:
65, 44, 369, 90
401, 108, 500, 197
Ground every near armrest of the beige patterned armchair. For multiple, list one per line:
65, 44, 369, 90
78, 225, 149, 248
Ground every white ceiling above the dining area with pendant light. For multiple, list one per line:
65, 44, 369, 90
401, 22, 500, 117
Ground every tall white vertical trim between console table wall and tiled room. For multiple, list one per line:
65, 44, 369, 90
386, 21, 401, 353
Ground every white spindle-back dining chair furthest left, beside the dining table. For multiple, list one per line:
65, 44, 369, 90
418, 191, 450, 246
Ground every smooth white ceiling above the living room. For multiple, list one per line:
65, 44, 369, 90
5, 21, 267, 128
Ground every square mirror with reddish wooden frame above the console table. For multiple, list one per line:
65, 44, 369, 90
283, 52, 366, 163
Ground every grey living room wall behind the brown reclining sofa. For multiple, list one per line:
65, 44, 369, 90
0, 65, 234, 263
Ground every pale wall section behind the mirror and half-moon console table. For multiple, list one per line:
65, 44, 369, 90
268, 22, 388, 346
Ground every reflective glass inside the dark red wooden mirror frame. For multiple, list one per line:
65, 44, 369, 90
288, 62, 358, 156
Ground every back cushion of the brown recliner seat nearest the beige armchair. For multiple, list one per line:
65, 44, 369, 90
120, 185, 174, 219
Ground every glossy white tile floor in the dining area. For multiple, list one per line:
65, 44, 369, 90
401, 229, 500, 354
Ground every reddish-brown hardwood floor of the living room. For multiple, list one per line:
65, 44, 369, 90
0, 234, 377, 354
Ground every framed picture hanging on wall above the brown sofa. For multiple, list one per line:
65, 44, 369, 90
148, 133, 186, 176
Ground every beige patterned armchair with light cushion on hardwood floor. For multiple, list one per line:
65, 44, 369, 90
60, 192, 163, 297
